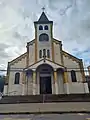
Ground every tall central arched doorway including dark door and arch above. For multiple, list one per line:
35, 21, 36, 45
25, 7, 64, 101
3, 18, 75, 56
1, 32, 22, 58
37, 64, 53, 94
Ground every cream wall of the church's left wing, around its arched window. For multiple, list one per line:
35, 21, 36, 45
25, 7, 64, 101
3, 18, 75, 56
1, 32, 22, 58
8, 56, 26, 95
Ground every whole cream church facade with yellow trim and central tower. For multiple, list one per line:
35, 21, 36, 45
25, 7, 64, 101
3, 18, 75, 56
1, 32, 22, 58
4, 12, 89, 95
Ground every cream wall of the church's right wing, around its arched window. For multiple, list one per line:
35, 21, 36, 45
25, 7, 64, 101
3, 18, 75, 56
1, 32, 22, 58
63, 56, 86, 93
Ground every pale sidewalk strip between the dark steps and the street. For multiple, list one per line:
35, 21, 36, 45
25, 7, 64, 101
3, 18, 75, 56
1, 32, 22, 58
0, 102, 90, 114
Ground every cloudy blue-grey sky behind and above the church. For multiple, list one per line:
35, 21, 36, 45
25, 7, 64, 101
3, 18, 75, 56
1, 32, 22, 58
0, 0, 90, 72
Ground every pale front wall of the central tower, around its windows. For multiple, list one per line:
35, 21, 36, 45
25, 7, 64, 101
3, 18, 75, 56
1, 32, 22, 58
37, 24, 52, 60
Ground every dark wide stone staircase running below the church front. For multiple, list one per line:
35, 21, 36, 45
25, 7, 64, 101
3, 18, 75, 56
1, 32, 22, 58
0, 94, 90, 104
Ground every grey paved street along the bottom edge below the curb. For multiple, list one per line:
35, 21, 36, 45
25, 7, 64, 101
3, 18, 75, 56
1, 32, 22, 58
0, 114, 90, 120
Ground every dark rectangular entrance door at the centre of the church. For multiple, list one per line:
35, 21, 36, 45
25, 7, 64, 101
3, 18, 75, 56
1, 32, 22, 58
40, 76, 52, 94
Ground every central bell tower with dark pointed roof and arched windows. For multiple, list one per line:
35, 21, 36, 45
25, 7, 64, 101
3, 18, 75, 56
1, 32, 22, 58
34, 11, 53, 61
